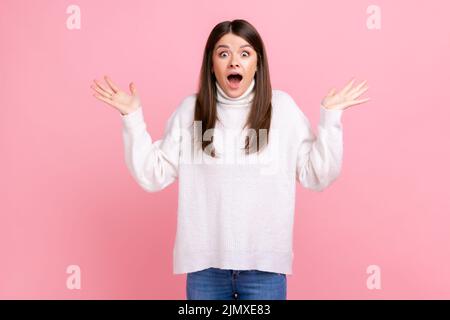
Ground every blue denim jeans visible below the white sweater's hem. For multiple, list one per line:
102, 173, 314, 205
186, 268, 286, 300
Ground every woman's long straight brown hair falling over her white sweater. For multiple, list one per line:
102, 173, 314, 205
194, 19, 272, 157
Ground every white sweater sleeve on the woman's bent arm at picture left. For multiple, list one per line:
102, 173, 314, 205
122, 106, 181, 192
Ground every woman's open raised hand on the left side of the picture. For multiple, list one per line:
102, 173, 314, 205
91, 76, 141, 116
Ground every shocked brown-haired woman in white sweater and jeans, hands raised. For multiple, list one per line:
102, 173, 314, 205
92, 20, 369, 299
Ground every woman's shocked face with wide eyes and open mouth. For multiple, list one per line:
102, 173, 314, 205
212, 33, 258, 98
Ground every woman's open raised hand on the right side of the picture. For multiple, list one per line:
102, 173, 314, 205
321, 79, 370, 110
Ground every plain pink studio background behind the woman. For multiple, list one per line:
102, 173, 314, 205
0, 0, 450, 299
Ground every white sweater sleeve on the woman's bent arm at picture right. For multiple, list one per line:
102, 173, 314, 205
294, 95, 344, 191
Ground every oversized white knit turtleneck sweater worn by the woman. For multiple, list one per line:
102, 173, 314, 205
122, 80, 343, 274
